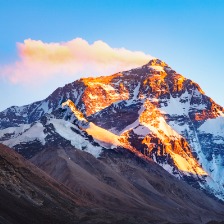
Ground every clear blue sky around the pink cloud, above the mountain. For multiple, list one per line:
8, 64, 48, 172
0, 0, 224, 110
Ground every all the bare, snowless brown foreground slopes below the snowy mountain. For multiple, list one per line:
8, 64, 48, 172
0, 145, 224, 224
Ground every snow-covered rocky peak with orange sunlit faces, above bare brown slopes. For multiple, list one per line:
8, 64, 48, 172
0, 59, 224, 200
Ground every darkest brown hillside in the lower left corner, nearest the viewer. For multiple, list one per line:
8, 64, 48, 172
0, 144, 161, 224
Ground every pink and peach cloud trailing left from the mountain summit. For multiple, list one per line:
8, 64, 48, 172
0, 38, 153, 84
